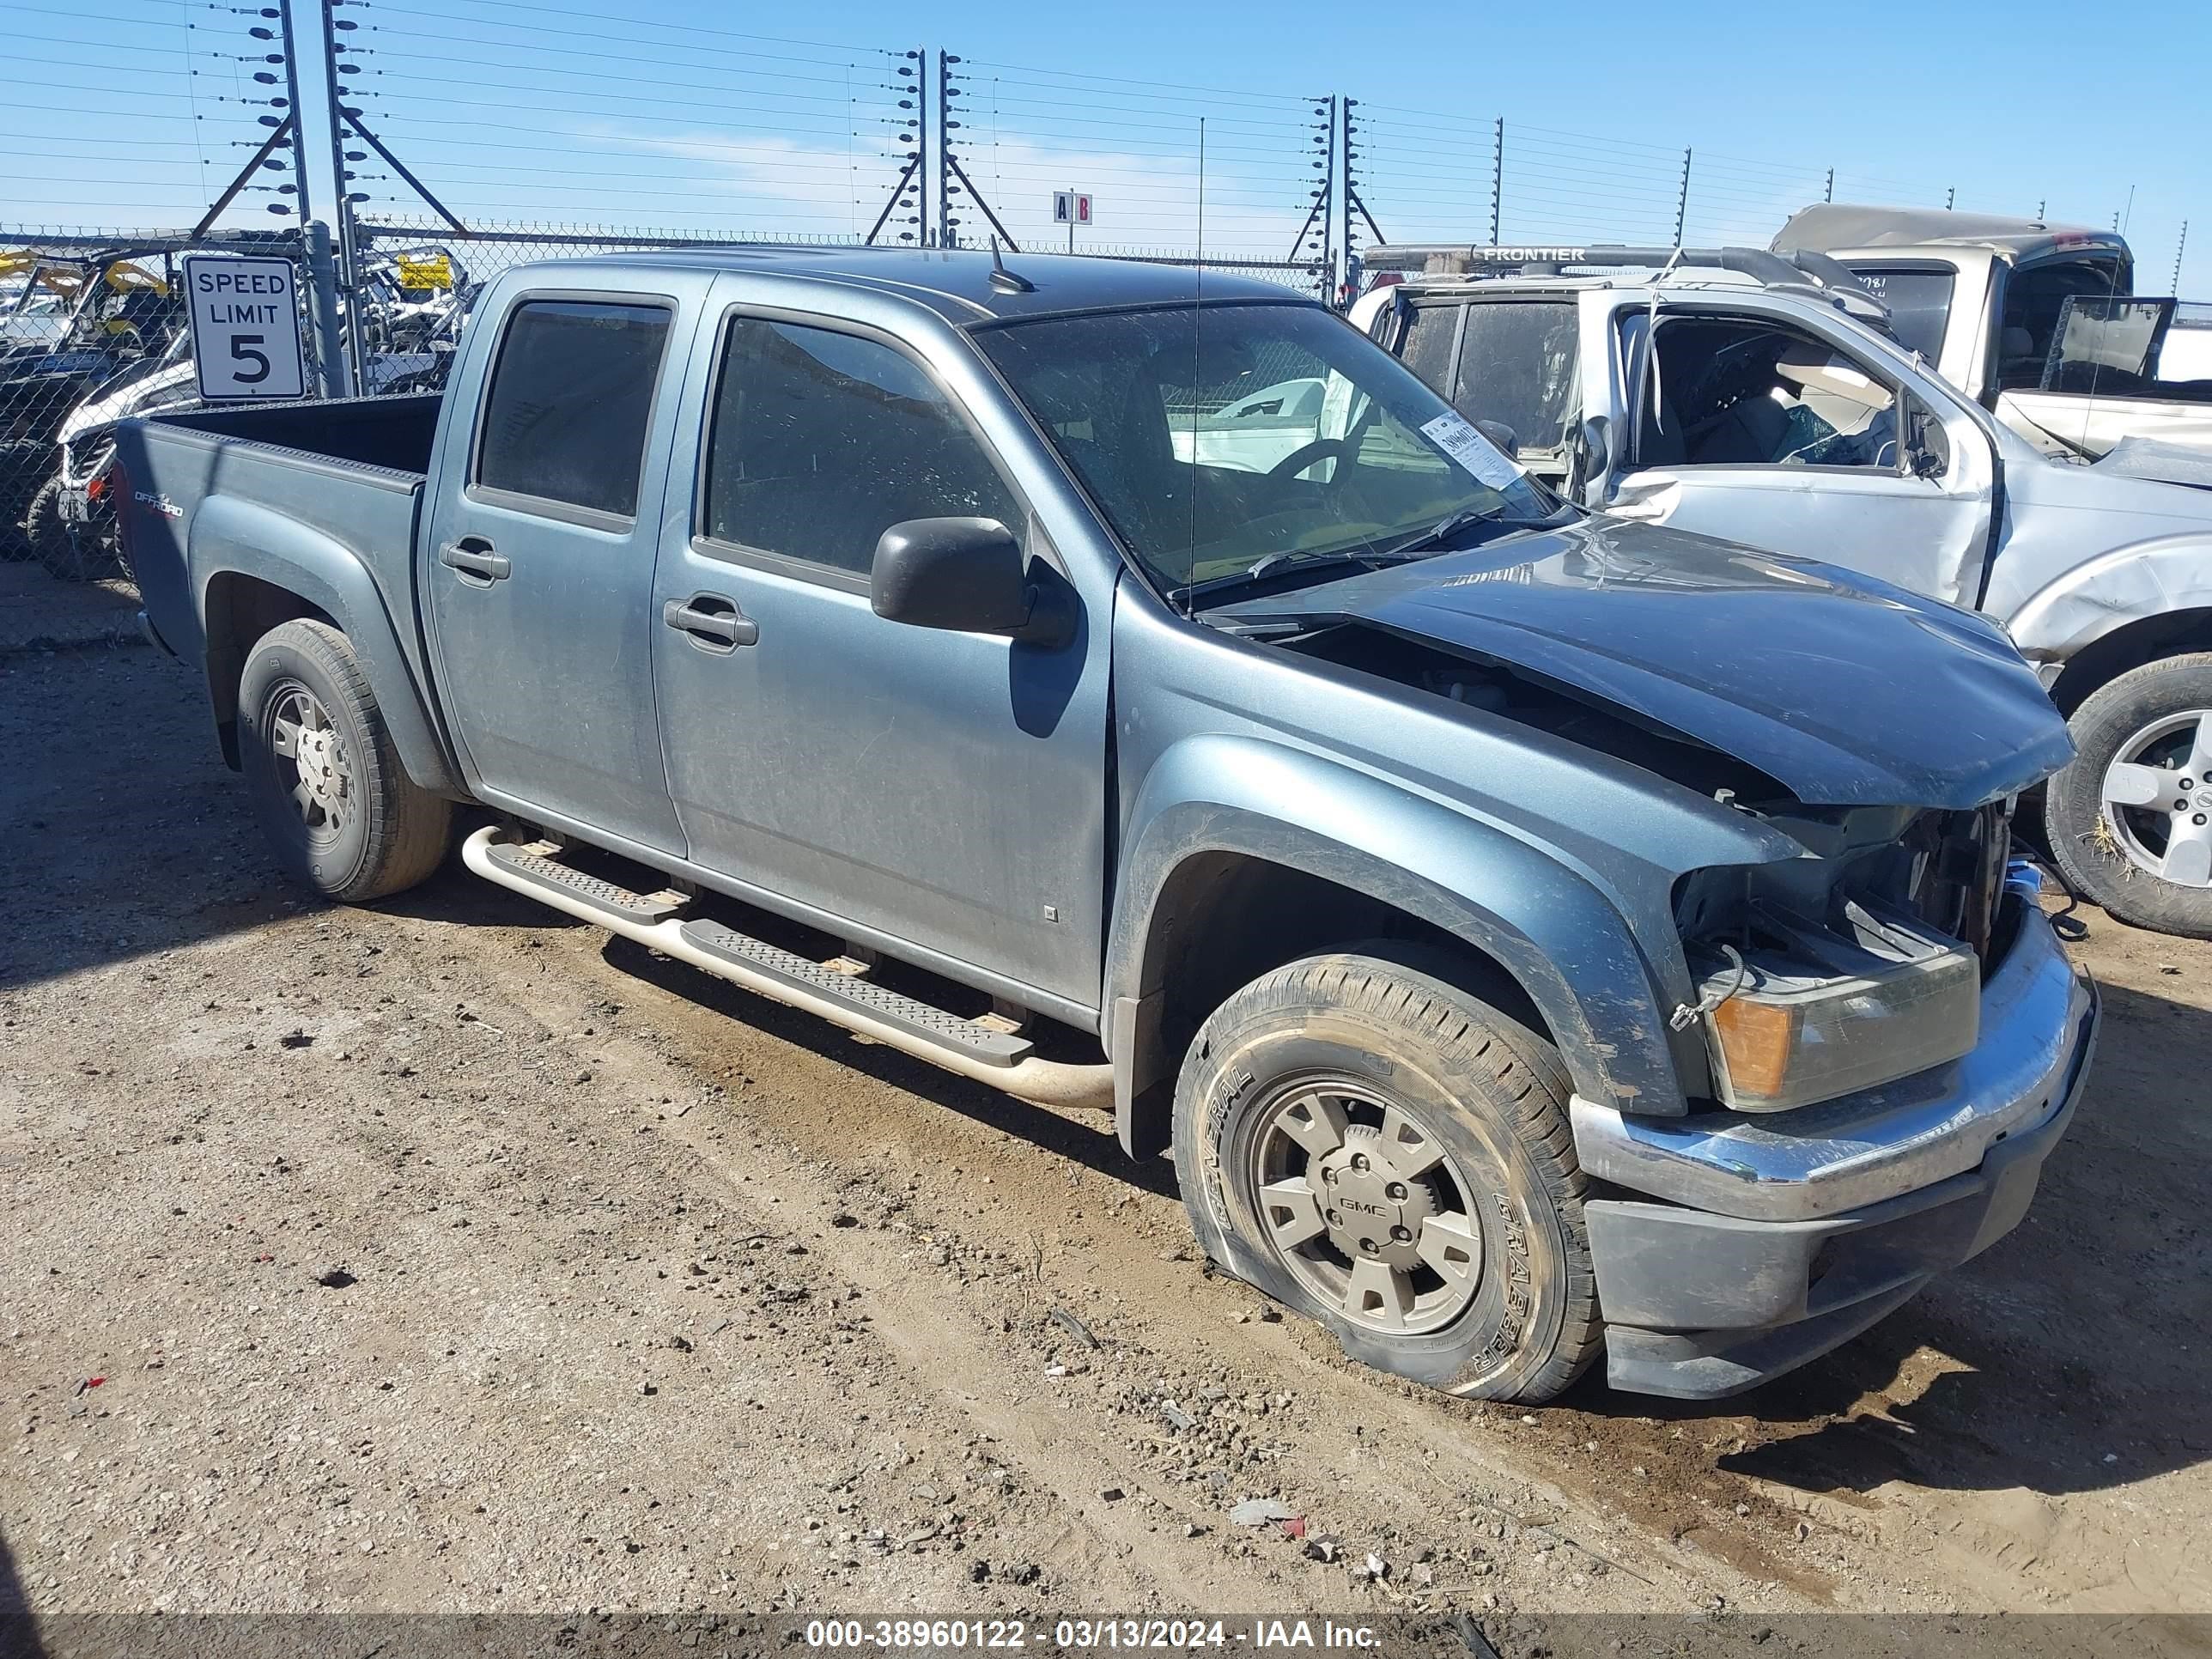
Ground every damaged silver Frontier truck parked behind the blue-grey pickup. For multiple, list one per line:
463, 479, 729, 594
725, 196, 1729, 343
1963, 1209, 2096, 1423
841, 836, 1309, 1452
1352, 246, 2212, 938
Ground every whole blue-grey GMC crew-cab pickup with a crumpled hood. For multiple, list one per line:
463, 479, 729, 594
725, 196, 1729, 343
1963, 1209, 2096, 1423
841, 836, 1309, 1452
119, 250, 2097, 1401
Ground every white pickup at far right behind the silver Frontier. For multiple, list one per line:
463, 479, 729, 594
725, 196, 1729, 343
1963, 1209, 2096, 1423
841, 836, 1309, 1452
1774, 201, 2212, 471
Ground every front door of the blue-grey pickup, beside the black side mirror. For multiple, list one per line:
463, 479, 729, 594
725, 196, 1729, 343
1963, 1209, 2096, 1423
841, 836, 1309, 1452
654, 288, 1109, 1011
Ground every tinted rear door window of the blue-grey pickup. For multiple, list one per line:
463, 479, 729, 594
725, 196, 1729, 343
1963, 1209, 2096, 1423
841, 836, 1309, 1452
476, 299, 671, 518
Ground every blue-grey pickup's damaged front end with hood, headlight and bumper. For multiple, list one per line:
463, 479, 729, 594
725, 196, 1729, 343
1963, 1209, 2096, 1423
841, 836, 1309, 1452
1228, 525, 2097, 1398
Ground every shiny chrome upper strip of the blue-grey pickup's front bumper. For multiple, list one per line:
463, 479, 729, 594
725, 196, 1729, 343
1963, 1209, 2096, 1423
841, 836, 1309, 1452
1571, 894, 2097, 1221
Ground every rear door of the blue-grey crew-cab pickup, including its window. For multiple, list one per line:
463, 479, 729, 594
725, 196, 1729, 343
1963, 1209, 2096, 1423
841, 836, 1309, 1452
420, 276, 706, 852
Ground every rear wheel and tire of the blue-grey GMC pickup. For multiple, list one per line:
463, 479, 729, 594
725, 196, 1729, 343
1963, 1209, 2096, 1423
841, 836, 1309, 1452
239, 619, 453, 905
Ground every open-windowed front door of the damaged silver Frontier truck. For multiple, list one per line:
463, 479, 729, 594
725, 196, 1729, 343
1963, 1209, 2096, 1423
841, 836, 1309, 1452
1589, 295, 1996, 606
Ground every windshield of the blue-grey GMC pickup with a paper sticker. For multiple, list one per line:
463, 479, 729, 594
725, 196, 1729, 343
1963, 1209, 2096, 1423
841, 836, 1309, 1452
975, 303, 1558, 588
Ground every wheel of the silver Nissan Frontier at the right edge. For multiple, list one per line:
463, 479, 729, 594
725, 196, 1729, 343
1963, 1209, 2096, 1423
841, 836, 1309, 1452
2044, 653, 2212, 938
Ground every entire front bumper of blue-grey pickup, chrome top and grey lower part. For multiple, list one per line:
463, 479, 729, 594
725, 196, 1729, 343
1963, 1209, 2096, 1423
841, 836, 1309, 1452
1573, 891, 2100, 1401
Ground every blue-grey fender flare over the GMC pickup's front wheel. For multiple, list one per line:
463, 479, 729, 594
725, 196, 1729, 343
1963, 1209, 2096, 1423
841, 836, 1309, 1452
1106, 737, 1686, 1137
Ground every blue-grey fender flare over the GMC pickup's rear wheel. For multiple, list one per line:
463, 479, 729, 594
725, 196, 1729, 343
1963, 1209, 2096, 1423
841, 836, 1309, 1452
191, 495, 467, 799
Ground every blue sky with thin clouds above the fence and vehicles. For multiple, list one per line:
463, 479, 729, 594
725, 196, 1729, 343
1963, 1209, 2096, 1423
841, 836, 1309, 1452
0, 0, 2212, 296
